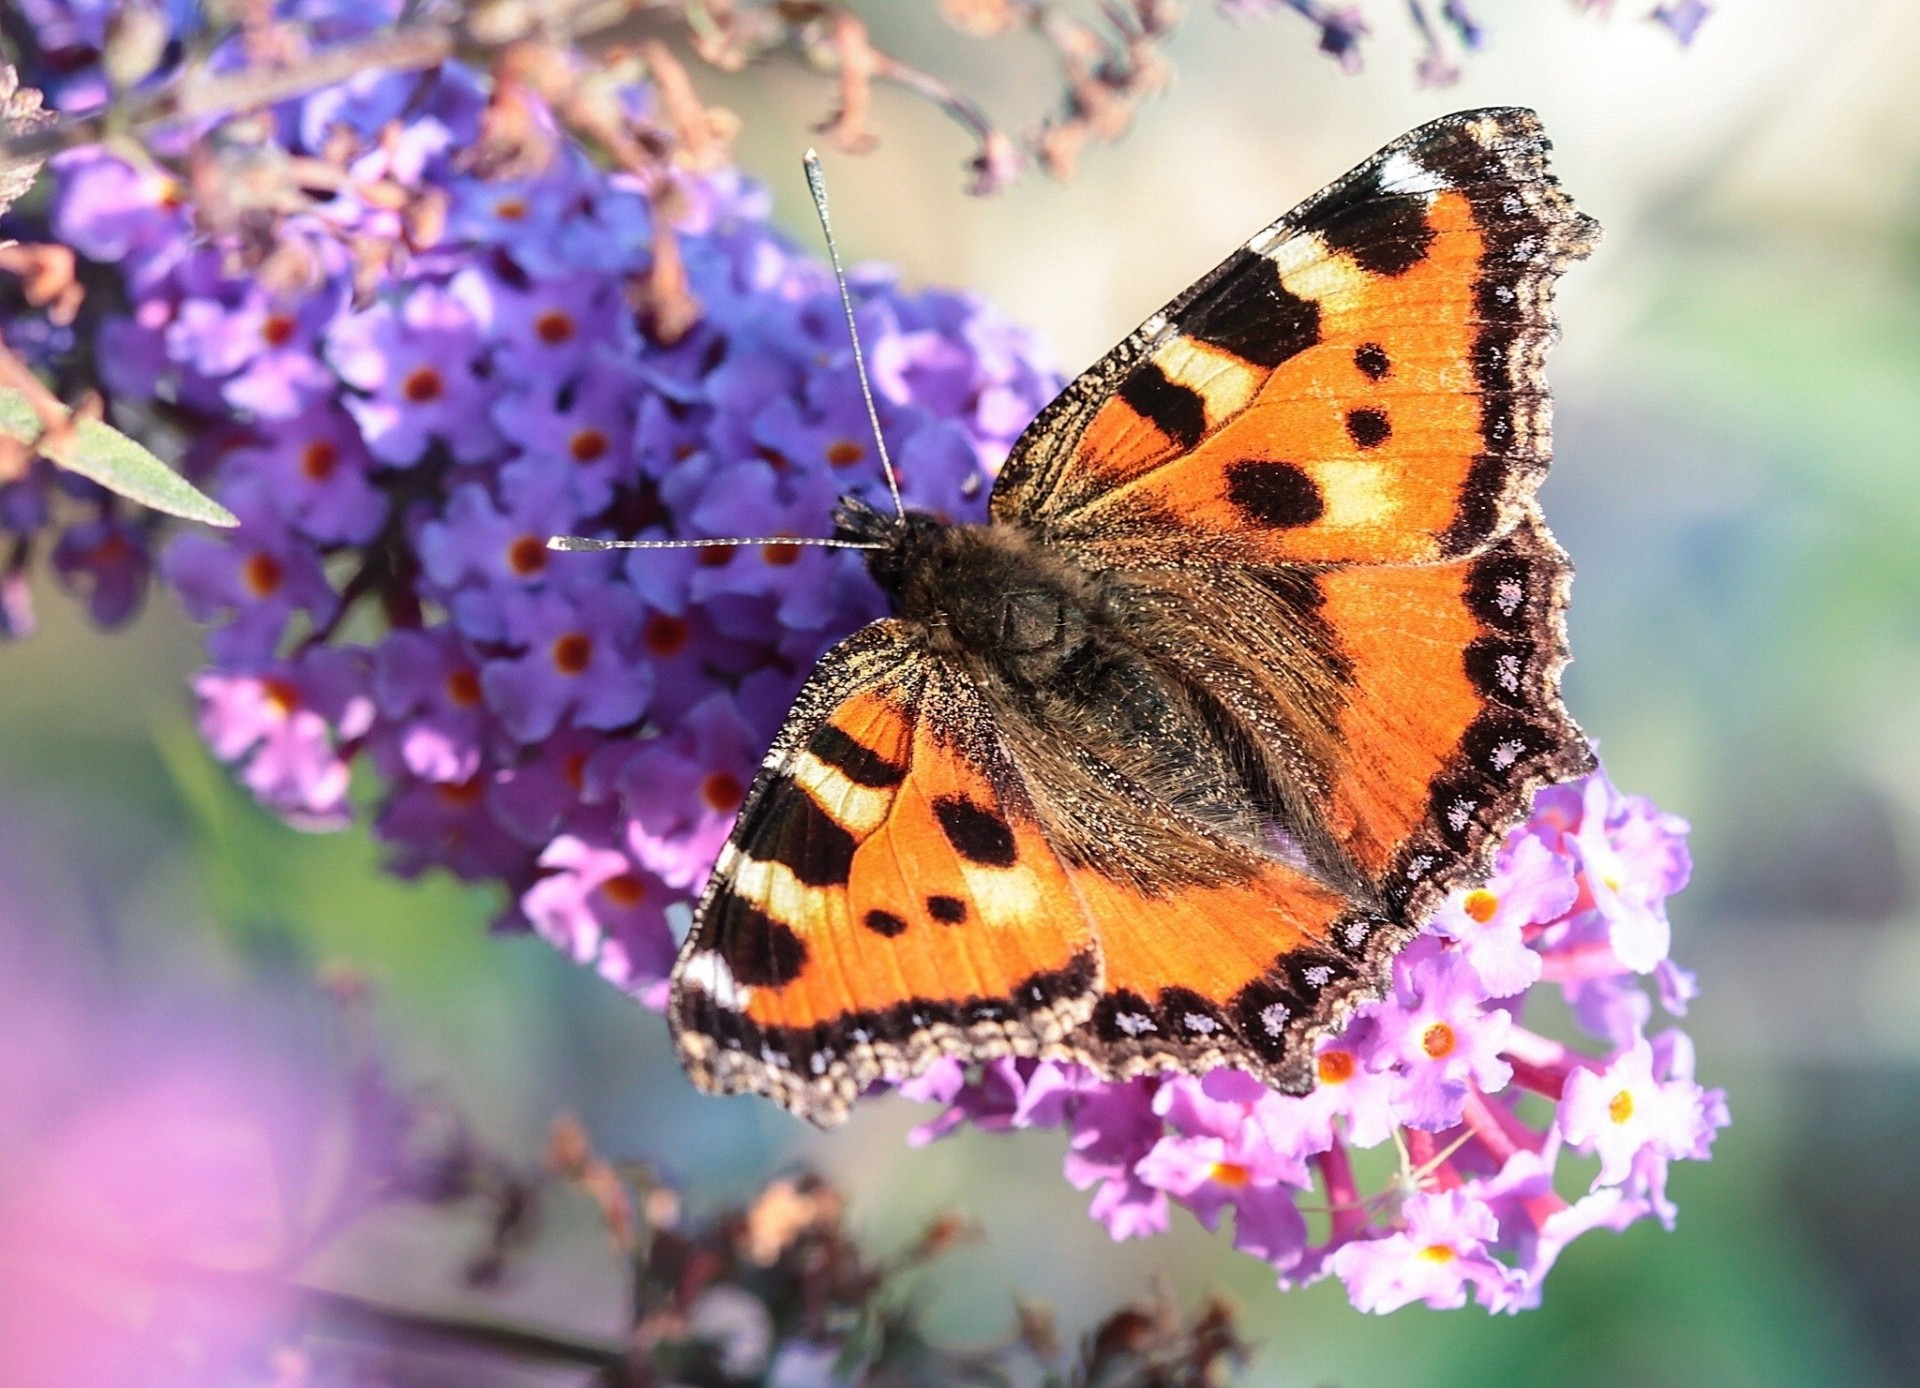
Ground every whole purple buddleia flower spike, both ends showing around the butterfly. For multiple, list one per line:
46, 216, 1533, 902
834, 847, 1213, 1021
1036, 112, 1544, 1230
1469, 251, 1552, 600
15, 8, 1726, 1309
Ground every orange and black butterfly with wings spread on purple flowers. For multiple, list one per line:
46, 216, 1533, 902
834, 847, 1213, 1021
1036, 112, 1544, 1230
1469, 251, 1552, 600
668, 109, 1597, 1127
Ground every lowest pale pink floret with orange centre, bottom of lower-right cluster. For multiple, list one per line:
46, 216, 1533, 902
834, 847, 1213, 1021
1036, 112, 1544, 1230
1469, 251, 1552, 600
1327, 1190, 1515, 1313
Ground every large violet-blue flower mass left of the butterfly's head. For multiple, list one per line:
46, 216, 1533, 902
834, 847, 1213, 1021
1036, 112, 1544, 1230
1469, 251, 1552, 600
41, 21, 1058, 1000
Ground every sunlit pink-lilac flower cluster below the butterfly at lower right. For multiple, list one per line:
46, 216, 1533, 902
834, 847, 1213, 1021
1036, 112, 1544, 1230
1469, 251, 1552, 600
900, 772, 1728, 1311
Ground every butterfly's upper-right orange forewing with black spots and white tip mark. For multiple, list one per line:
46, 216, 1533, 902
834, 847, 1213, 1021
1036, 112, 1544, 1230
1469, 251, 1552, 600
993, 109, 1596, 566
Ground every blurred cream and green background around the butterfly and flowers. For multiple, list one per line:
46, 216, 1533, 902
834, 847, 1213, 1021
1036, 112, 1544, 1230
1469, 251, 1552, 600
0, 0, 1920, 1388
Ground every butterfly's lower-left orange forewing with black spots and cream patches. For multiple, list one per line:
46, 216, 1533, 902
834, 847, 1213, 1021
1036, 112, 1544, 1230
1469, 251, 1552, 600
670, 620, 1100, 1125
